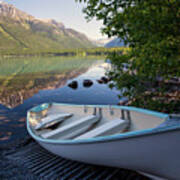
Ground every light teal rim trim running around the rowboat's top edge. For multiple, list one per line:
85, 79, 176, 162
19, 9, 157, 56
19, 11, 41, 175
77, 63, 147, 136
27, 103, 180, 145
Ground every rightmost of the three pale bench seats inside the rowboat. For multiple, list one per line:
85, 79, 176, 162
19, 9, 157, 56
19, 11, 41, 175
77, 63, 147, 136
75, 119, 128, 139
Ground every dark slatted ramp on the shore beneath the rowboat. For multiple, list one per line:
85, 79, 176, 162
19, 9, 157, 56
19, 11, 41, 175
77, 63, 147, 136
0, 140, 148, 180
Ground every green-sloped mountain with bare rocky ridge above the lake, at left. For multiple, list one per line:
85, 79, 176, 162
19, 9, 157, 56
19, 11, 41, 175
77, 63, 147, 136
0, 1, 95, 53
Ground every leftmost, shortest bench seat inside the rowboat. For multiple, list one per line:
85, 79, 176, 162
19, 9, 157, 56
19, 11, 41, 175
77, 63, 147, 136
35, 113, 73, 130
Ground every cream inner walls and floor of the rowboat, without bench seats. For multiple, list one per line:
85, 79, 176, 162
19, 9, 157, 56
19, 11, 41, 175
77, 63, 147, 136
28, 104, 165, 140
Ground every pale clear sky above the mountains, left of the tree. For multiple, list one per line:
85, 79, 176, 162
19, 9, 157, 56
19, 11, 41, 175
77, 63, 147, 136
4, 0, 105, 40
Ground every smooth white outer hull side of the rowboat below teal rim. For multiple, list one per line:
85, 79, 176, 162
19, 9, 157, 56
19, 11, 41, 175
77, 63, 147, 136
39, 131, 180, 179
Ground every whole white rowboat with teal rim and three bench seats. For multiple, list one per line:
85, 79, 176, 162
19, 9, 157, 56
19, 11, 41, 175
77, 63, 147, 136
27, 103, 180, 179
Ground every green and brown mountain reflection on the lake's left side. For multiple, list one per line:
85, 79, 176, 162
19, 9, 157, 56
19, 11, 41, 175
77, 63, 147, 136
0, 57, 94, 108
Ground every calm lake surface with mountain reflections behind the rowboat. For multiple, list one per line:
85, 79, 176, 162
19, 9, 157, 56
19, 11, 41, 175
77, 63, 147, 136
0, 57, 124, 144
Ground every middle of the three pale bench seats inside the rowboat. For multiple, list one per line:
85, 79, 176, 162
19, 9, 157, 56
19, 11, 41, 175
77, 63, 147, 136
41, 115, 100, 139
